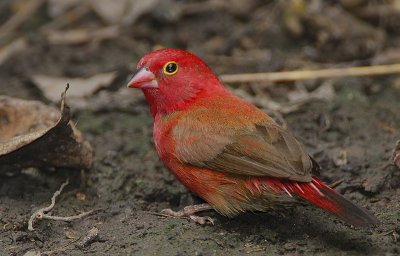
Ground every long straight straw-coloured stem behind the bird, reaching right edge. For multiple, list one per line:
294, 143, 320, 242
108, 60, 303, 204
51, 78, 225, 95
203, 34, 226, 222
219, 64, 400, 83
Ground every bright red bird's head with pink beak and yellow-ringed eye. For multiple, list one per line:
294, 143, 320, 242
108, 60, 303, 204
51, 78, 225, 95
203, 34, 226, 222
128, 48, 226, 117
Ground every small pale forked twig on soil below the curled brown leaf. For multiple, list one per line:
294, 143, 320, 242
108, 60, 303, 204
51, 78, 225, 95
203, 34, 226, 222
28, 179, 93, 231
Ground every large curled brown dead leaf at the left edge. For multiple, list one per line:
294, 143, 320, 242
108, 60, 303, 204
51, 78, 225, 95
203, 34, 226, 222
0, 87, 93, 172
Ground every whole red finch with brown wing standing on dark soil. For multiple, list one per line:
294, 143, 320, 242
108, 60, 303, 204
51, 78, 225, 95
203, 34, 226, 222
128, 49, 378, 227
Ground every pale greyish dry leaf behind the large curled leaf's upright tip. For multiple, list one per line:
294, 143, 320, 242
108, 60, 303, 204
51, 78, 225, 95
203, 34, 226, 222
32, 72, 117, 102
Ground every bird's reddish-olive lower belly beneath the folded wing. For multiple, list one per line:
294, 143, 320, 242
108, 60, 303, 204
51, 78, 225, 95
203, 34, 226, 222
159, 156, 287, 217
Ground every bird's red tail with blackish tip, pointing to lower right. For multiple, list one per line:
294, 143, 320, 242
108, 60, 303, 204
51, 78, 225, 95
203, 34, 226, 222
267, 177, 379, 227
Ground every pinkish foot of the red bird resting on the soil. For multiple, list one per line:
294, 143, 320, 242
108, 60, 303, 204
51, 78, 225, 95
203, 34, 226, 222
161, 204, 214, 225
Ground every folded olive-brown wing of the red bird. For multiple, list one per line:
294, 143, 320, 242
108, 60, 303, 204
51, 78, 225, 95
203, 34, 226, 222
173, 108, 316, 182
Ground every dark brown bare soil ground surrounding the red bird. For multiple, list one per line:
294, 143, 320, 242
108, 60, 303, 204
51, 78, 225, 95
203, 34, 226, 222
0, 1, 400, 255
